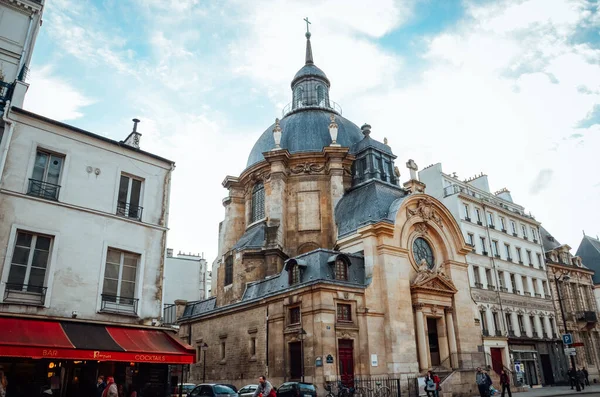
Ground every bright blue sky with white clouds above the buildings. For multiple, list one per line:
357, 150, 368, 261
25, 0, 600, 263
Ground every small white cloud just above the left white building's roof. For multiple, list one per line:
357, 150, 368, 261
24, 65, 94, 121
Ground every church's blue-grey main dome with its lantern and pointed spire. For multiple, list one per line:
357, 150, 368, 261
247, 32, 363, 167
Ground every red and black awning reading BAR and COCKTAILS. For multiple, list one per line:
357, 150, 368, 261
0, 317, 196, 364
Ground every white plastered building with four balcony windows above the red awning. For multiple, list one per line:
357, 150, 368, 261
0, 107, 174, 324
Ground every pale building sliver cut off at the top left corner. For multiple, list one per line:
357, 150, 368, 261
0, 0, 44, 108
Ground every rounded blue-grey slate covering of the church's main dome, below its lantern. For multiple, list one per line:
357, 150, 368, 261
247, 109, 363, 167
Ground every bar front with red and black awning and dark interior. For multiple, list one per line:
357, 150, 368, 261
0, 317, 195, 397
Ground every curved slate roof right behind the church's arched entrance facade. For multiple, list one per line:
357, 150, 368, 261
335, 179, 407, 237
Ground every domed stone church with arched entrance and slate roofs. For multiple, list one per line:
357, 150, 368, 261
179, 26, 485, 391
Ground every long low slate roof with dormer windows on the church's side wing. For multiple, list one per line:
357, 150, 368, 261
179, 249, 370, 321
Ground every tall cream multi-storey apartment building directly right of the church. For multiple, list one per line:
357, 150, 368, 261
419, 163, 566, 386
